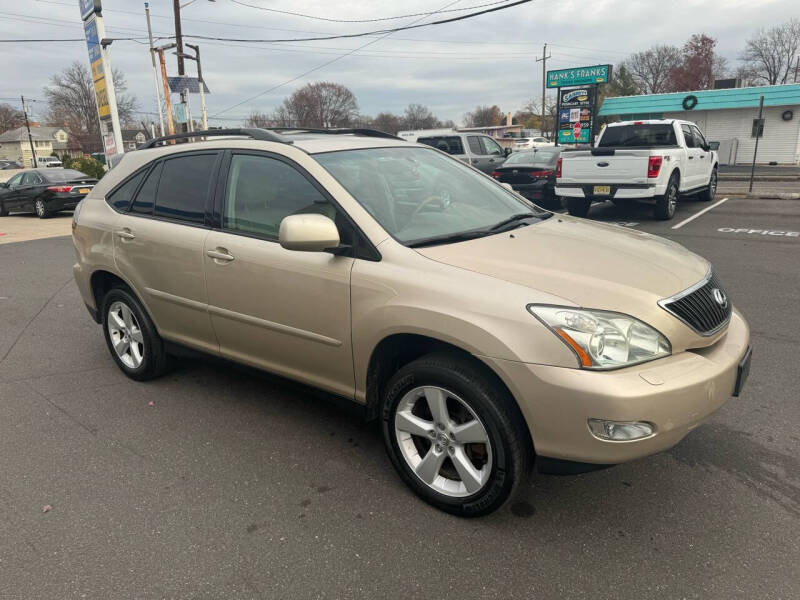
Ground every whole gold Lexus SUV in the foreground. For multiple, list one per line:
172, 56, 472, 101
73, 129, 750, 516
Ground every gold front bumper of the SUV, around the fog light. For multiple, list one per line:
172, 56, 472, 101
481, 310, 750, 464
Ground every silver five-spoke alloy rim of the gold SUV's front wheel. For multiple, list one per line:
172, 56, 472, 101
394, 386, 492, 498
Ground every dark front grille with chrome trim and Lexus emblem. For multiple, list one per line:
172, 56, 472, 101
659, 273, 733, 335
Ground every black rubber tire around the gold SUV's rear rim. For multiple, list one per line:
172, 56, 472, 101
101, 287, 167, 381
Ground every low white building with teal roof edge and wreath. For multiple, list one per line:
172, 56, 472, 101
598, 84, 800, 165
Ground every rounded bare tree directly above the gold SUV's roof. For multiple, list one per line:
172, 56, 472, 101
280, 81, 358, 127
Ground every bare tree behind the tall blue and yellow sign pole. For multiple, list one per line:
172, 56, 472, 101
44, 60, 136, 135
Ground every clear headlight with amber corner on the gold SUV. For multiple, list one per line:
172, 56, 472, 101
528, 304, 672, 369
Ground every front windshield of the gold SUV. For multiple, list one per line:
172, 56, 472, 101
314, 147, 550, 245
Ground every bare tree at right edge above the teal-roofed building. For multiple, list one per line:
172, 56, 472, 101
739, 19, 800, 85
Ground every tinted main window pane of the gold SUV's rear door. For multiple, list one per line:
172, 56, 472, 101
154, 152, 217, 224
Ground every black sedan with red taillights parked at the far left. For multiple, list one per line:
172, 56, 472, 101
0, 168, 97, 219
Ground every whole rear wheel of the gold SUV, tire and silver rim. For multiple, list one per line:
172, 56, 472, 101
103, 287, 167, 381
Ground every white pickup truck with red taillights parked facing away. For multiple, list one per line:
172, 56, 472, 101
555, 119, 719, 220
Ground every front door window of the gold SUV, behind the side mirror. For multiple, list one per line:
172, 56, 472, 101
222, 154, 341, 240
